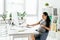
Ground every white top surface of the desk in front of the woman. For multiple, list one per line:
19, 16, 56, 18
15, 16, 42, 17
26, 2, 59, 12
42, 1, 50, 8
8, 26, 39, 34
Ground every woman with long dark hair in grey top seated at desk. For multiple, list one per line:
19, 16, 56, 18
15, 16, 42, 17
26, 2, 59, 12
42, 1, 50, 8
27, 12, 50, 40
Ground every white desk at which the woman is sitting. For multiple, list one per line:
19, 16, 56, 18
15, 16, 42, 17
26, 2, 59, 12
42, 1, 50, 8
8, 27, 39, 40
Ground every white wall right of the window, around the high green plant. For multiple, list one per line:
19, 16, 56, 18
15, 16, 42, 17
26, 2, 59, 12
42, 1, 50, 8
38, 0, 60, 19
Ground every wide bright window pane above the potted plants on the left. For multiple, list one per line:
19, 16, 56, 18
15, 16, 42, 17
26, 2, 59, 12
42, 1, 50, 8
6, 0, 25, 12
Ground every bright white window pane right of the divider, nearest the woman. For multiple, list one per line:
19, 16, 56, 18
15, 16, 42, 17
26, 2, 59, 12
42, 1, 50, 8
25, 0, 37, 15
